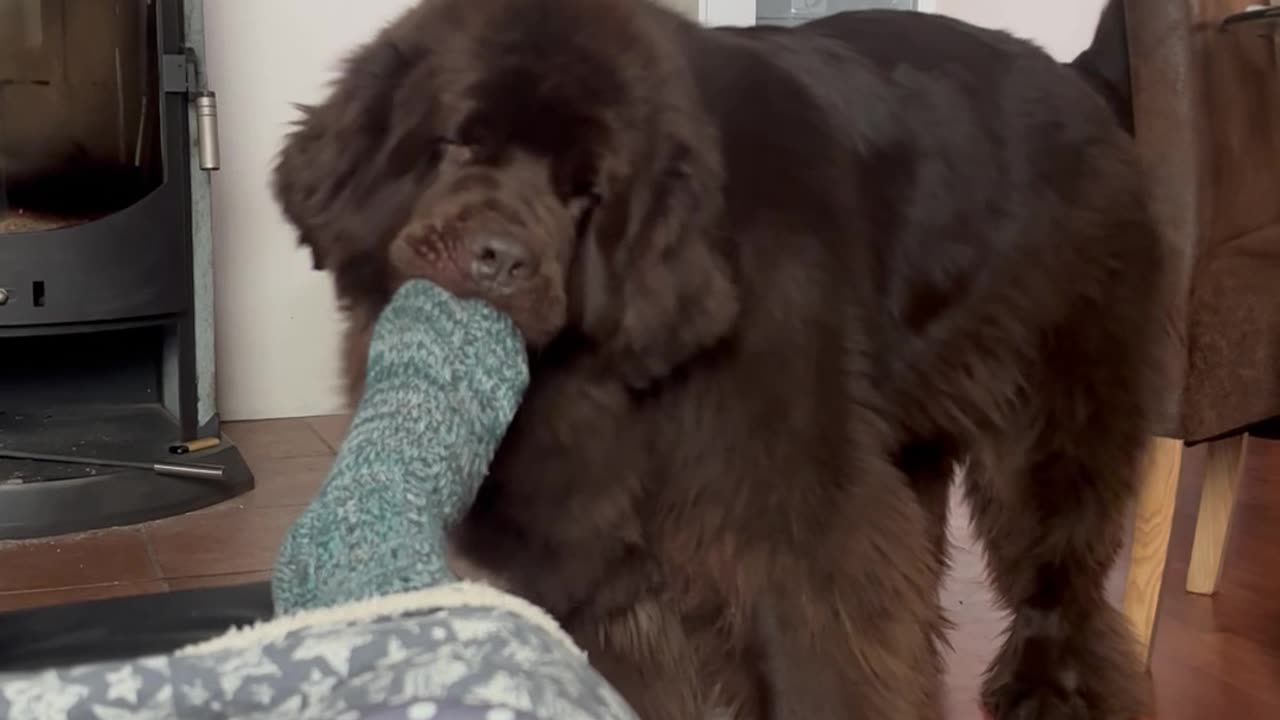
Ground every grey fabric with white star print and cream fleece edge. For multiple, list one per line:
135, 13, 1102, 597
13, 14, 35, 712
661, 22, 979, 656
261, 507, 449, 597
0, 588, 635, 720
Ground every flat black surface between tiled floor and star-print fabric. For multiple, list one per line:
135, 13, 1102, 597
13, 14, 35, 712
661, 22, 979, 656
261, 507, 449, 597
0, 583, 273, 673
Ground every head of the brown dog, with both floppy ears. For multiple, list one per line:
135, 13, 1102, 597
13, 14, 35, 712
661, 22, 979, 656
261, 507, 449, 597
274, 0, 737, 387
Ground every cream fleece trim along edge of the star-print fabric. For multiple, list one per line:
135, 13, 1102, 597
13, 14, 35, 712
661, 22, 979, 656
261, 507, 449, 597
174, 582, 585, 657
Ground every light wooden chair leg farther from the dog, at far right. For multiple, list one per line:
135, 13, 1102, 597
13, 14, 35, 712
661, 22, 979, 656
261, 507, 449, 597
1187, 433, 1245, 594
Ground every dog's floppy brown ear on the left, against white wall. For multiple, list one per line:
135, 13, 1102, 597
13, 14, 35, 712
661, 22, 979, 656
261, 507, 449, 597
273, 36, 422, 278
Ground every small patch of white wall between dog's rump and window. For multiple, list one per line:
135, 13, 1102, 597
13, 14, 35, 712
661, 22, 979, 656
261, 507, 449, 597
934, 0, 1106, 60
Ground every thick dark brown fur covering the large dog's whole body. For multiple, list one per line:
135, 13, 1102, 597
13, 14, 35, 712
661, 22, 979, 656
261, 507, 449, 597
275, 0, 1166, 720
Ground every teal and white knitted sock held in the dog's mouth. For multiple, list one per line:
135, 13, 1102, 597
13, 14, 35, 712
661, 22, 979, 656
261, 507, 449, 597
271, 281, 529, 615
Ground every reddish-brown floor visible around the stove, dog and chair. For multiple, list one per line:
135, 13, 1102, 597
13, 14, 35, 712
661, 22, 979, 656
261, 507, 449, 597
0, 418, 1280, 720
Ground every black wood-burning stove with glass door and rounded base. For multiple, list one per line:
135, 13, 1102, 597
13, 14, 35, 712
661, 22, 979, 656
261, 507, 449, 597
0, 0, 253, 539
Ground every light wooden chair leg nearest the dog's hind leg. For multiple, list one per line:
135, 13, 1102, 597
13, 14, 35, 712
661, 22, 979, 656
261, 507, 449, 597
1123, 437, 1183, 660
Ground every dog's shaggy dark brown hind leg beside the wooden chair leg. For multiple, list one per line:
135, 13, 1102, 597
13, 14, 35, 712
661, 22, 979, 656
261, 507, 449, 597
964, 308, 1151, 720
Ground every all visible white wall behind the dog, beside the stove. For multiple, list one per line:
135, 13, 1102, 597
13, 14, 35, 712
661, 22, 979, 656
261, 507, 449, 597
205, 0, 1105, 420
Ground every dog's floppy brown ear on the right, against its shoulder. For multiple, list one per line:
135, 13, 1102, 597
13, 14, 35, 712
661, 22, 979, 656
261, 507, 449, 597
571, 141, 739, 389
